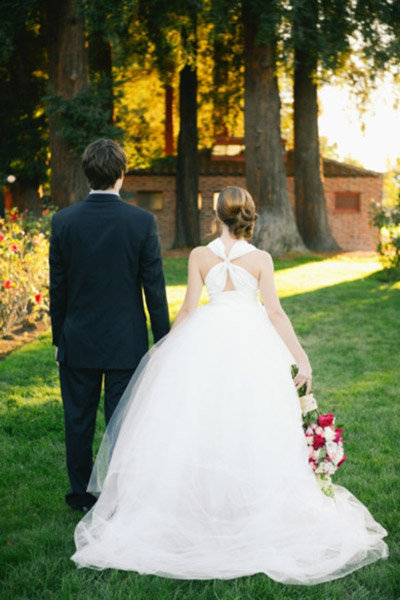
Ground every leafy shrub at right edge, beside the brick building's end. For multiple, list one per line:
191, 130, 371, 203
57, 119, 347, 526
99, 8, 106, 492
371, 194, 400, 280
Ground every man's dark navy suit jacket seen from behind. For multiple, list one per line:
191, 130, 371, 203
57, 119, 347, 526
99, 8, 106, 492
50, 193, 169, 369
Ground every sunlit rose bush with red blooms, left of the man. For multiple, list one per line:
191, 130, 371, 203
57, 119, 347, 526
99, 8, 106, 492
0, 208, 54, 336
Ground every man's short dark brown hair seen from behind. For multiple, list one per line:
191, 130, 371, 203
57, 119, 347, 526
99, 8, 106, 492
82, 138, 126, 190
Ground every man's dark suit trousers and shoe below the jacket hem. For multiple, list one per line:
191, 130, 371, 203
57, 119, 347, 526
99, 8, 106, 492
59, 364, 135, 509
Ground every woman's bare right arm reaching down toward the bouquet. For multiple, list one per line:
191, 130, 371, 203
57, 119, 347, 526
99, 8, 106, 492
259, 251, 312, 394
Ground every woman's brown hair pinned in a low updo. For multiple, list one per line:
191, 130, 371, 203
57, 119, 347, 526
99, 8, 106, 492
216, 186, 257, 240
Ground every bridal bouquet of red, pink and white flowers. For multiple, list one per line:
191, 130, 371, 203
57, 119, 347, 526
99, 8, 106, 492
292, 365, 347, 498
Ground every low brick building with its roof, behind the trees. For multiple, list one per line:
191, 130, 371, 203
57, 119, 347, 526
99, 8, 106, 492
122, 145, 382, 250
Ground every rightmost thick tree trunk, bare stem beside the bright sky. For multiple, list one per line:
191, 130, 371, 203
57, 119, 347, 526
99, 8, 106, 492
294, 50, 339, 250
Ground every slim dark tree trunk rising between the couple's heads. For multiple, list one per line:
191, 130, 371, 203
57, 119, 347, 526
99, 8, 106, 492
174, 65, 200, 248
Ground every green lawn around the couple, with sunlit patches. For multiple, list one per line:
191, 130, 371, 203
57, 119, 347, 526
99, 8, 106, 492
0, 256, 400, 600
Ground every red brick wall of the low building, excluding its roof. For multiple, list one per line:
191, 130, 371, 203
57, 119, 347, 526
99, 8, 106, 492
124, 173, 382, 250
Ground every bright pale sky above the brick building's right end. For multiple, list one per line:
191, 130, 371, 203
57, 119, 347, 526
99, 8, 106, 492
319, 81, 400, 171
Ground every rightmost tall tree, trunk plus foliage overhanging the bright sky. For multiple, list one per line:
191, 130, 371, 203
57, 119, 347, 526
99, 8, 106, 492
287, 0, 400, 250
